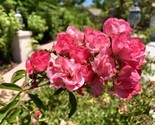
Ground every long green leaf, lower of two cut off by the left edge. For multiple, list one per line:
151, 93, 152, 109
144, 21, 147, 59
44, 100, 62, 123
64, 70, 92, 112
0, 96, 19, 124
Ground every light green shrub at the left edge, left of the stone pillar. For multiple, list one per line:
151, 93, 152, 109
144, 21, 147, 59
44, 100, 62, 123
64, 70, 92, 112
0, 6, 21, 61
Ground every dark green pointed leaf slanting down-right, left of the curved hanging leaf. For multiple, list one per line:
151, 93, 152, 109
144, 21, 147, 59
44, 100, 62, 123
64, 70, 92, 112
28, 94, 45, 109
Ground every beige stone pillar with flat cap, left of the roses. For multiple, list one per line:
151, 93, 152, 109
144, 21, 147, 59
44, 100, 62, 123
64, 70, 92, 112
12, 30, 32, 62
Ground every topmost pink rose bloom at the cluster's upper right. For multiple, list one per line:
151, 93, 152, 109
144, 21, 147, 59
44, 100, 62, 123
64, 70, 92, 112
103, 18, 132, 36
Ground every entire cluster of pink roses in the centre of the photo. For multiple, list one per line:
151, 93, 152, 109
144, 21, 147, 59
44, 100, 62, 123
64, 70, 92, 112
26, 18, 145, 99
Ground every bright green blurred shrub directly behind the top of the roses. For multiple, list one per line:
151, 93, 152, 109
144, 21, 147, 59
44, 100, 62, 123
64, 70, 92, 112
46, 7, 102, 38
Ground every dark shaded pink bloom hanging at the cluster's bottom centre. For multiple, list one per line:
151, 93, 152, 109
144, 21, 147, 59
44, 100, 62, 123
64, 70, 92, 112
88, 76, 103, 97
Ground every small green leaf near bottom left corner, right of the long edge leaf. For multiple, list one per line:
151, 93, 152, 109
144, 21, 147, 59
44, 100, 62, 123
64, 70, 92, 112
7, 108, 21, 123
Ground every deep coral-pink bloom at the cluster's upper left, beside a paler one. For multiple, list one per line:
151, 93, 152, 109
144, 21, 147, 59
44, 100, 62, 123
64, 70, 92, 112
53, 32, 75, 54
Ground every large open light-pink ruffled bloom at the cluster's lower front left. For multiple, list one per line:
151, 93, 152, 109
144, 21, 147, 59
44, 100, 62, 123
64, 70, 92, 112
47, 57, 84, 91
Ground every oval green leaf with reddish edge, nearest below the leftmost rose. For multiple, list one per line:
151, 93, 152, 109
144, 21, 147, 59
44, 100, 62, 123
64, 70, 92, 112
11, 70, 26, 83
